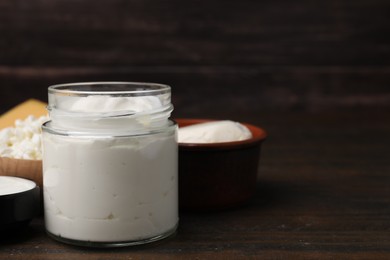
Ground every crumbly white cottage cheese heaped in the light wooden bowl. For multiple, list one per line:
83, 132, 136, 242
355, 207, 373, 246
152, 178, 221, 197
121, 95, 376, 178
0, 116, 49, 160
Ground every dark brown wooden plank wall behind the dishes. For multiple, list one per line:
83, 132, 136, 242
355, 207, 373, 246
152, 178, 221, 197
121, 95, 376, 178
0, 0, 390, 117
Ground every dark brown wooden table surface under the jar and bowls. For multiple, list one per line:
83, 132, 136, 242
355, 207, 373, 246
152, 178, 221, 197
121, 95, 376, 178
0, 109, 390, 259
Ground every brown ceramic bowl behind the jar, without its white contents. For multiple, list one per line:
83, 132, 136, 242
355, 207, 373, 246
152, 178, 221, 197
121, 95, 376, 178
175, 119, 267, 211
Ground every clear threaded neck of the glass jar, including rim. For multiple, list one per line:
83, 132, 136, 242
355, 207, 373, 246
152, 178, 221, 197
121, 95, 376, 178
48, 82, 173, 133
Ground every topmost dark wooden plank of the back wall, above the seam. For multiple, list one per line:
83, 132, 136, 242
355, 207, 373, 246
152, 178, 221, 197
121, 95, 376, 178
0, 0, 390, 66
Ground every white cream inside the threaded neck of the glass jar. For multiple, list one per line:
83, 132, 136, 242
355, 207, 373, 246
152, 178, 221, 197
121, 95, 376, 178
50, 95, 170, 132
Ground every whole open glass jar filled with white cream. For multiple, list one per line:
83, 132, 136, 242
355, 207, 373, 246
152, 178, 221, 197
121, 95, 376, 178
42, 82, 178, 247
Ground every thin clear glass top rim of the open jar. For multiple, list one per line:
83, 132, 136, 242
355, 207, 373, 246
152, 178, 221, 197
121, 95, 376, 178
48, 81, 171, 96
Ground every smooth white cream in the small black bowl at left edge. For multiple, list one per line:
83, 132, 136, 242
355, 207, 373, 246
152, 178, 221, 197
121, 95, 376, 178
0, 176, 36, 196
